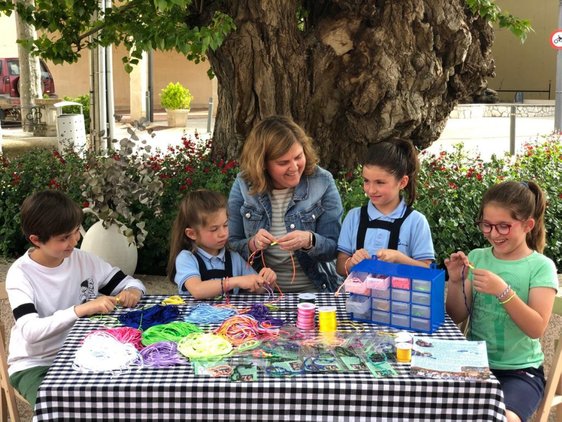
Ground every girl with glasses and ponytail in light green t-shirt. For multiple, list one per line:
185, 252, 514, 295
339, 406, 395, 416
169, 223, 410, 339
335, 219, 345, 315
445, 181, 558, 422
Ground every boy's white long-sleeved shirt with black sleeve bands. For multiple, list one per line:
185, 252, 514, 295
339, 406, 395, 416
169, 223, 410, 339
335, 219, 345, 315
6, 249, 145, 375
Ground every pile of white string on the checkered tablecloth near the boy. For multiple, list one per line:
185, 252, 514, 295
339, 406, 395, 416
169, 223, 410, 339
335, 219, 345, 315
72, 331, 143, 372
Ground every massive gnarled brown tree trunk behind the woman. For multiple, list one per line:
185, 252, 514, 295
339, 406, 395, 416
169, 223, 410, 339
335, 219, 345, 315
203, 0, 494, 170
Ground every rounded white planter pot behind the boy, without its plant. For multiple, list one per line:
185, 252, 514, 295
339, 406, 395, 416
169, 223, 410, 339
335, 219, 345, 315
80, 221, 138, 275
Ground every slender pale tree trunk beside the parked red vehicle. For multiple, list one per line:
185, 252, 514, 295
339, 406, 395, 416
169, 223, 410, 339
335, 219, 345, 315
16, 0, 43, 132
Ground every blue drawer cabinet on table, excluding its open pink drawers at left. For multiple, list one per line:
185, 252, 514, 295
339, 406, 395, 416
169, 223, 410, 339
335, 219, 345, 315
348, 259, 445, 333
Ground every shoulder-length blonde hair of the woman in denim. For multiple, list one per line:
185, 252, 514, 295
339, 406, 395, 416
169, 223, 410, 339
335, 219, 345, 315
240, 116, 318, 195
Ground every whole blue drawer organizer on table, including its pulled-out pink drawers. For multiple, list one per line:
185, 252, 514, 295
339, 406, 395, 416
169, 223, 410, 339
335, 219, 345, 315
345, 259, 445, 333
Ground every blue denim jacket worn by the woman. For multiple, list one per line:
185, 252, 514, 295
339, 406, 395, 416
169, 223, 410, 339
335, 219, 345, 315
228, 167, 343, 292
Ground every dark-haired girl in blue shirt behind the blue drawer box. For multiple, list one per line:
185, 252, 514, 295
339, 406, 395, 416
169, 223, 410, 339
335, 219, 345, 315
337, 138, 435, 275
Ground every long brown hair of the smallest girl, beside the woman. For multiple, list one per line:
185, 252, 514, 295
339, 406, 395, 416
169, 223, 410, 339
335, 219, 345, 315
167, 189, 227, 282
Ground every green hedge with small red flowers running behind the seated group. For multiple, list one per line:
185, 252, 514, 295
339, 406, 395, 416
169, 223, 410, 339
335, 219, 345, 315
0, 134, 562, 274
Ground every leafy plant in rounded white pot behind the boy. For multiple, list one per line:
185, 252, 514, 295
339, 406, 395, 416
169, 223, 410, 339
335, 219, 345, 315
81, 123, 163, 274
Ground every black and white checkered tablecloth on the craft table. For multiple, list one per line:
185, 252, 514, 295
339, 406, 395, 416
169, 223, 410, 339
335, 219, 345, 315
34, 294, 505, 421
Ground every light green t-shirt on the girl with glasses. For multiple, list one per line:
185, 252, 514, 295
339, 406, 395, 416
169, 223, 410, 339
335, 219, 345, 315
468, 247, 558, 369
